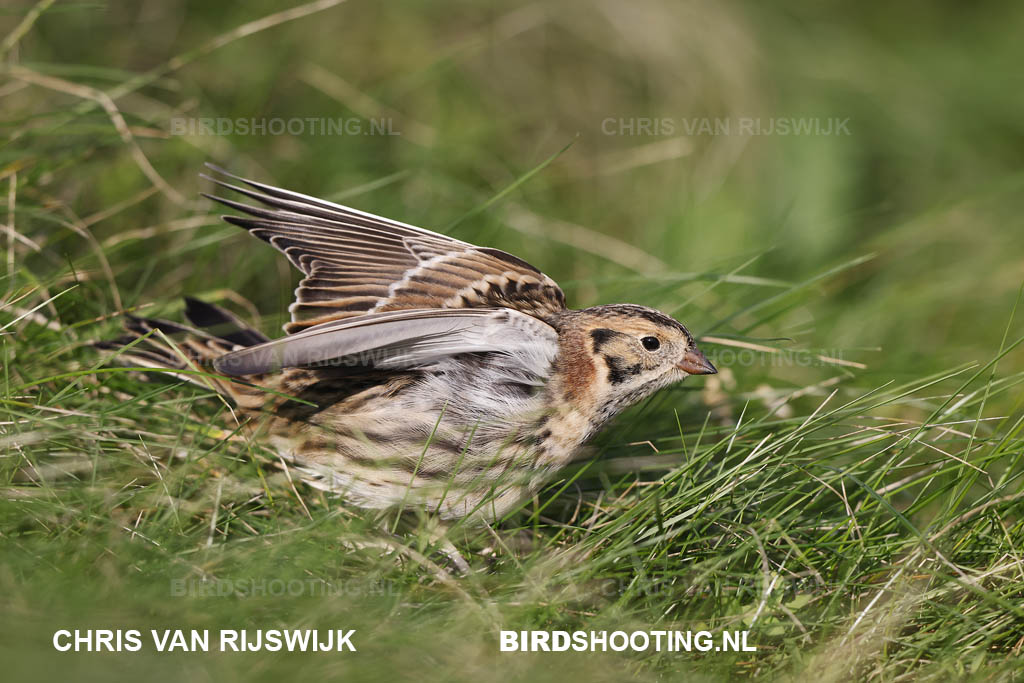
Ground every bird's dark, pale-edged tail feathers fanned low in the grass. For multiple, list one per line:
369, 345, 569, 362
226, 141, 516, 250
94, 297, 269, 401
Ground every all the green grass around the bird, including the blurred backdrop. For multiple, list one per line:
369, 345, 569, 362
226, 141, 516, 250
0, 0, 1024, 681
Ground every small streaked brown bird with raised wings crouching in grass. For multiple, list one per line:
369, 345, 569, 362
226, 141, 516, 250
100, 169, 716, 520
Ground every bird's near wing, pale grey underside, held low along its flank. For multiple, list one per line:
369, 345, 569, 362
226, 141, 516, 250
214, 308, 558, 378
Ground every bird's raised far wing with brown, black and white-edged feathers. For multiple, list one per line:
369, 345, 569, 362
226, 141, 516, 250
199, 166, 565, 334
